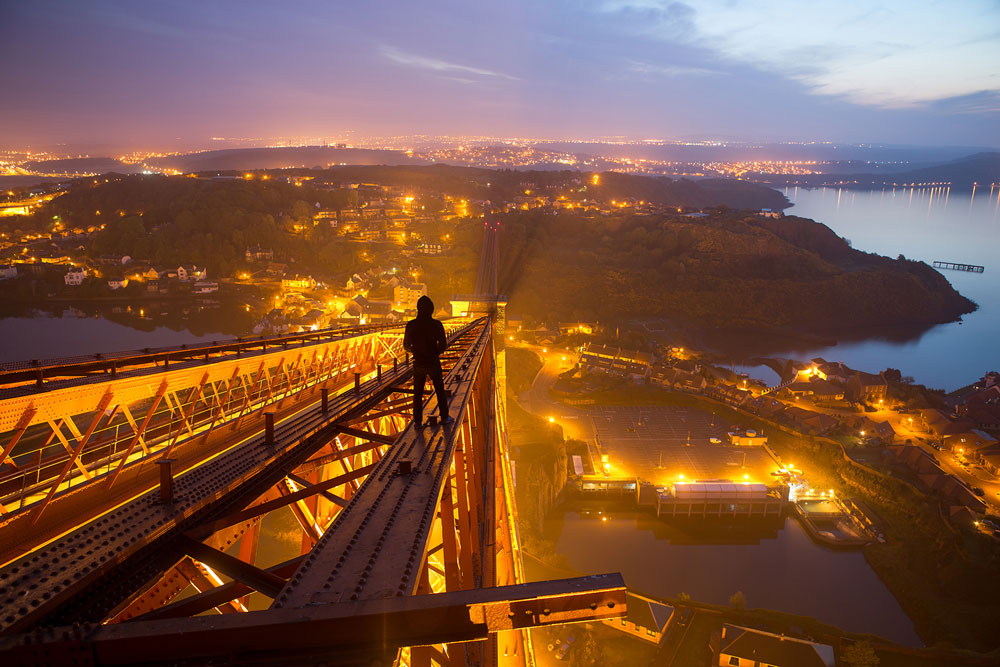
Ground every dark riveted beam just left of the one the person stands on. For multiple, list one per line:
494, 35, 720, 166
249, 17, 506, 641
0, 326, 481, 632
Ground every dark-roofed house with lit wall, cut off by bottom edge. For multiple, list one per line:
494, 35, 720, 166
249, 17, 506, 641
715, 623, 836, 667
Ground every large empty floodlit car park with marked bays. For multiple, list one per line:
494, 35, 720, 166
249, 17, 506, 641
587, 406, 777, 486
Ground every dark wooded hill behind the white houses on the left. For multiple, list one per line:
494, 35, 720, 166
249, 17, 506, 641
21, 176, 353, 277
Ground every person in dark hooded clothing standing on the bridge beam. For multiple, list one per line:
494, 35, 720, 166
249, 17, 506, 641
403, 296, 451, 428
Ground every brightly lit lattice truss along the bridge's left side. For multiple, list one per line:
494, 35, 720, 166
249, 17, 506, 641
0, 321, 461, 524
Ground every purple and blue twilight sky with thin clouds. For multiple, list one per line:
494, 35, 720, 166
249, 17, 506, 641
0, 0, 1000, 148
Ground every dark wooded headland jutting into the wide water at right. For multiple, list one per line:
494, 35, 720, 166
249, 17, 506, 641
488, 212, 975, 333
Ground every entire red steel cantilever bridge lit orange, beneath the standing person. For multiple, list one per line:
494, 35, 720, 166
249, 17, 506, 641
0, 310, 626, 665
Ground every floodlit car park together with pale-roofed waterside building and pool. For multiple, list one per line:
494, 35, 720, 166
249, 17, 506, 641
571, 406, 874, 549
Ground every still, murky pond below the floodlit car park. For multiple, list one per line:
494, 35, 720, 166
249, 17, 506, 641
546, 511, 922, 646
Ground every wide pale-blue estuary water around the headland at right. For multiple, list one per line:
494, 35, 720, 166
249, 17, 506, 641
736, 188, 1000, 390
